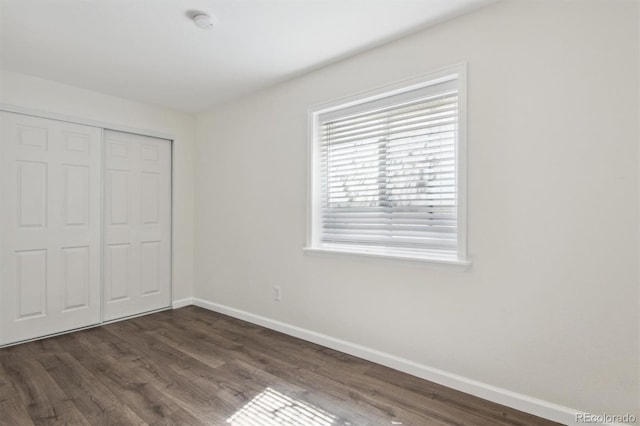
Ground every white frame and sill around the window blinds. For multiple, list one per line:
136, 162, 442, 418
304, 63, 471, 266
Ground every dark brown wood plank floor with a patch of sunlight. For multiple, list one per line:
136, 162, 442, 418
0, 307, 556, 426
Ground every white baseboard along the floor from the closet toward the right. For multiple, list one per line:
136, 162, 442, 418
181, 297, 580, 425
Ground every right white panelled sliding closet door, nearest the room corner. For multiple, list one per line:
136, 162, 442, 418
103, 130, 171, 321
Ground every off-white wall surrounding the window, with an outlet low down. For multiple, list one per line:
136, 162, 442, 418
195, 0, 640, 415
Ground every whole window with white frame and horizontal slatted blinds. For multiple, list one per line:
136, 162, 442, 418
307, 67, 467, 263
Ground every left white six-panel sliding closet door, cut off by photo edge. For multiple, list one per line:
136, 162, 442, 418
0, 112, 102, 344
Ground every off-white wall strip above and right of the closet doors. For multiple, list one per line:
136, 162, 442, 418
0, 71, 195, 300
